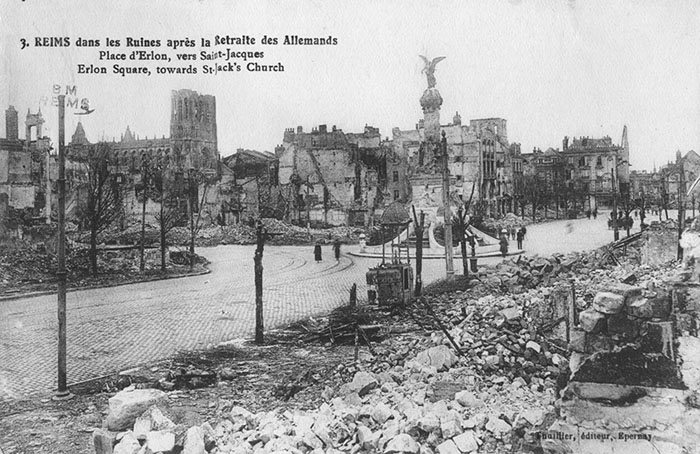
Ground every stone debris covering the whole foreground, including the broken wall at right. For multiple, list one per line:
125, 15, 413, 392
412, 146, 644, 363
2, 220, 700, 454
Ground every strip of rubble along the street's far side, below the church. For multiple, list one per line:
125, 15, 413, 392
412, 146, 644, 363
0, 219, 362, 296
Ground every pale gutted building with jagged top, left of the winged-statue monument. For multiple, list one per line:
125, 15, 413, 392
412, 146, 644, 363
276, 125, 393, 225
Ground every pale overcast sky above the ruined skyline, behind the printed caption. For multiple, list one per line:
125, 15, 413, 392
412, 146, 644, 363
0, 0, 700, 169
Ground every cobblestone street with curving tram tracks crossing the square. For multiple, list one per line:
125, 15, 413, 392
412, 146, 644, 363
0, 211, 638, 400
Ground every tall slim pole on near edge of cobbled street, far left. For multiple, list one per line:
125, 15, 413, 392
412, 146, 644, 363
54, 95, 73, 400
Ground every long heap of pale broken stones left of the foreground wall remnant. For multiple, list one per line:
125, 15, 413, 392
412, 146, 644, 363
87, 224, 688, 454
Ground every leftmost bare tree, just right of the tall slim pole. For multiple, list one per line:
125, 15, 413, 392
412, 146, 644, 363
79, 142, 121, 276
